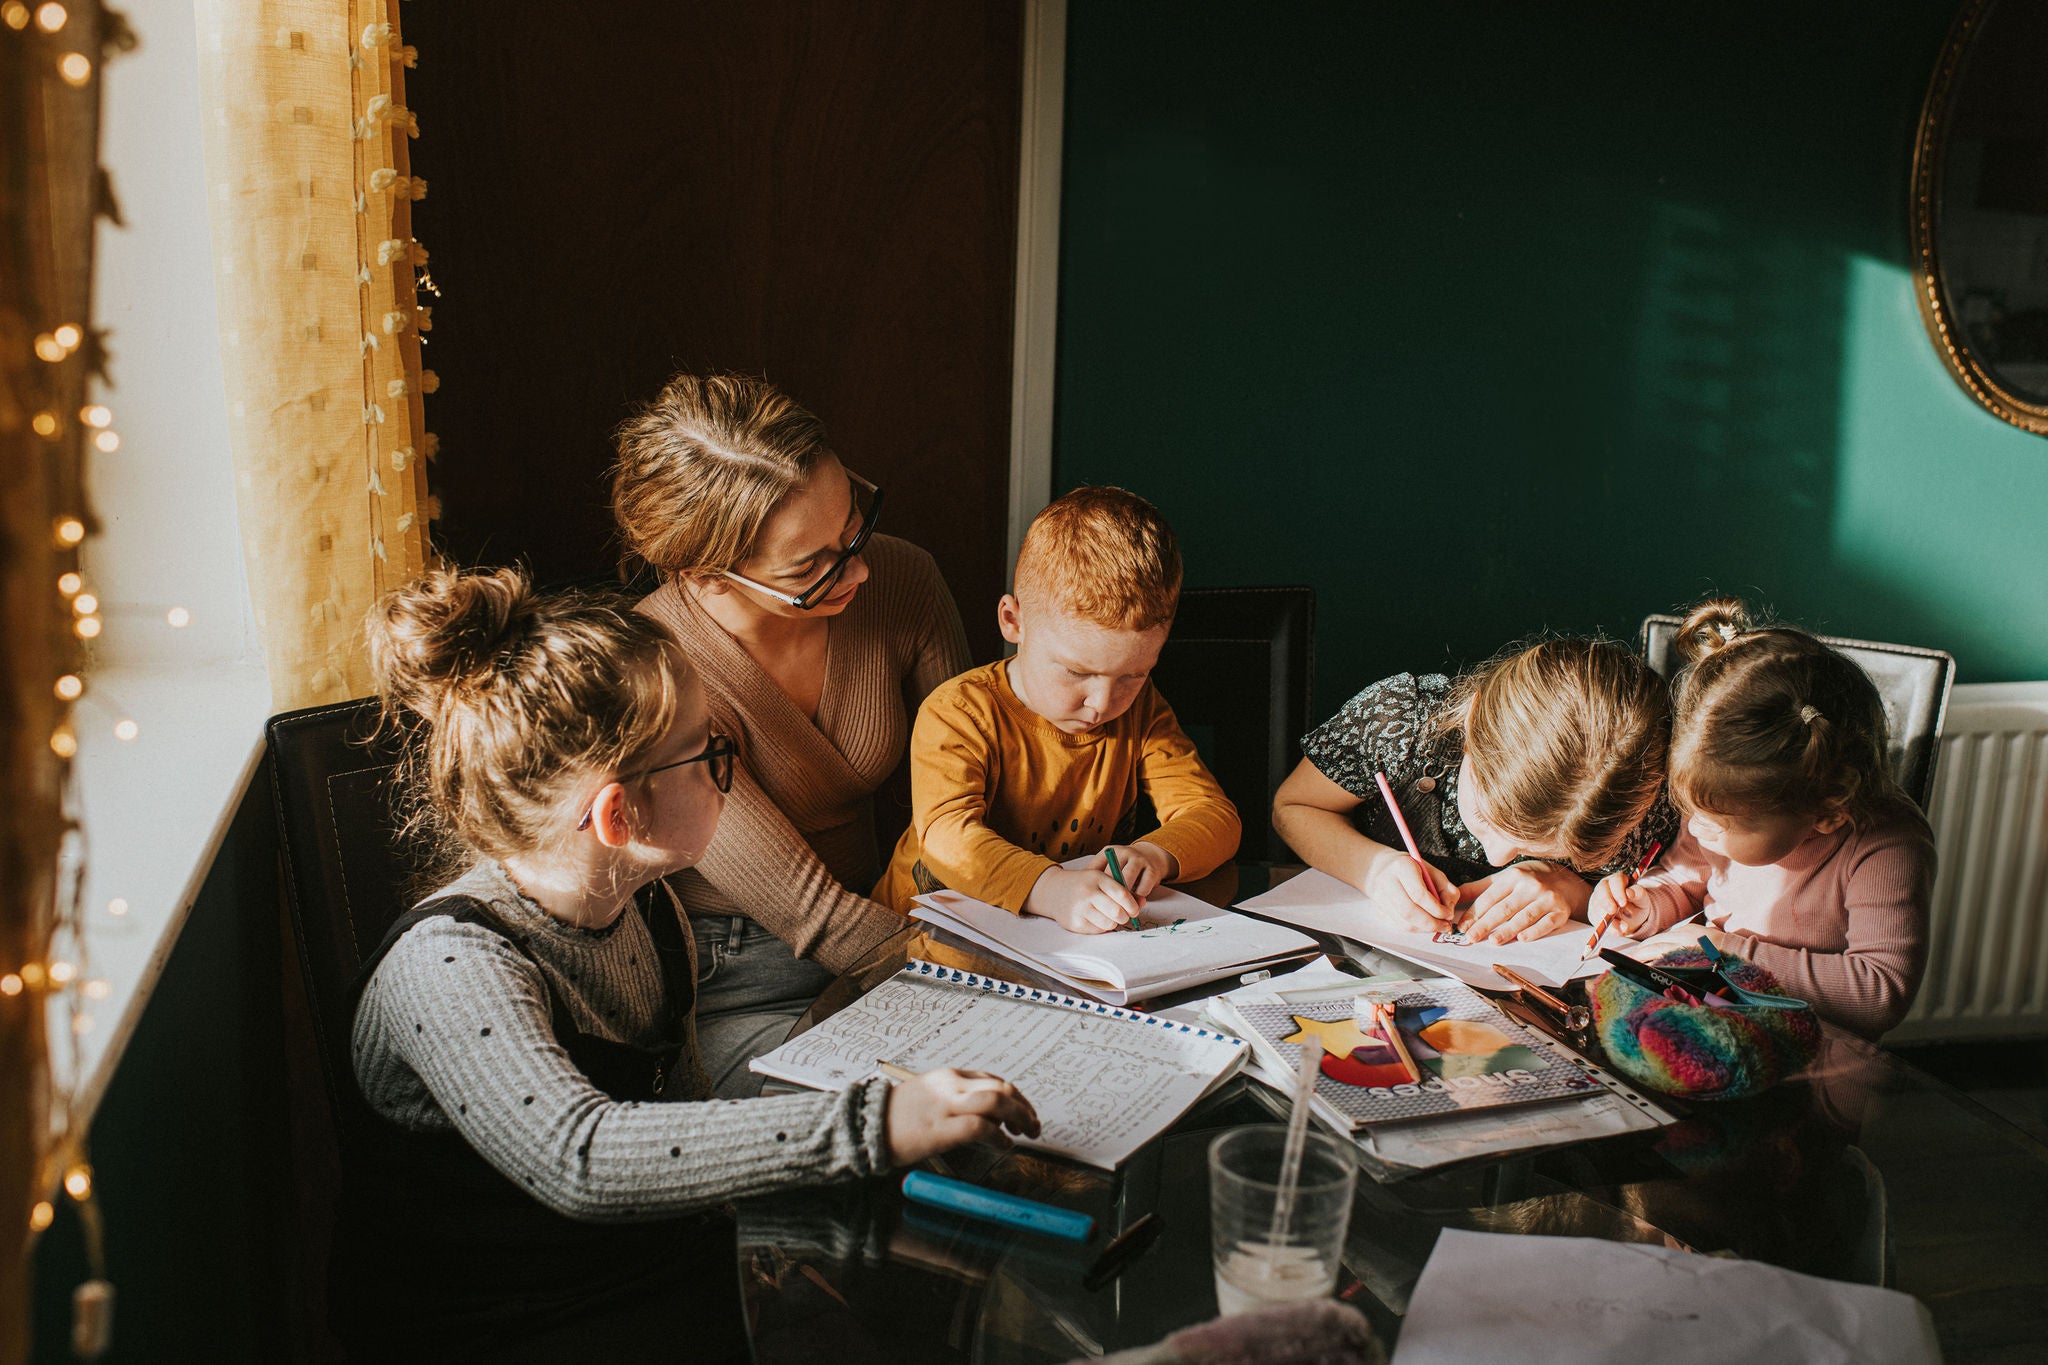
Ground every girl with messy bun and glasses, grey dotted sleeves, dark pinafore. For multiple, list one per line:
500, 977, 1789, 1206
346, 569, 1038, 1361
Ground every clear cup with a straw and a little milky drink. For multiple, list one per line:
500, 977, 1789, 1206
1208, 1124, 1358, 1316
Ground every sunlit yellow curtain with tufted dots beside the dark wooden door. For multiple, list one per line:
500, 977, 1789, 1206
197, 0, 436, 710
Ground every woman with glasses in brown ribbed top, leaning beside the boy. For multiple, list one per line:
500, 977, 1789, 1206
612, 375, 971, 1099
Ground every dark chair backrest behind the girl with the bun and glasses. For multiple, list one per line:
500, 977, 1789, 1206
266, 700, 416, 1150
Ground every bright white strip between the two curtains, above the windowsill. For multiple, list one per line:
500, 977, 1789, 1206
80, 0, 260, 667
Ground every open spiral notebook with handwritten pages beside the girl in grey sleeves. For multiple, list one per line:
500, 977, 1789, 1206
750, 958, 1249, 1171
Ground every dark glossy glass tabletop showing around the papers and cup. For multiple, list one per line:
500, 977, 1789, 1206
739, 868, 2048, 1365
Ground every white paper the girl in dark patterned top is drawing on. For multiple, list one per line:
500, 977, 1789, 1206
1239, 868, 1622, 990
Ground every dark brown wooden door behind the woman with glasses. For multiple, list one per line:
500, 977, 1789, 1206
406, 0, 1022, 659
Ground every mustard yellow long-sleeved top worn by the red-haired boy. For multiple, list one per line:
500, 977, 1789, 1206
874, 659, 1241, 913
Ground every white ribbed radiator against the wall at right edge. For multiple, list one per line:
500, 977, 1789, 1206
1886, 681, 2048, 1042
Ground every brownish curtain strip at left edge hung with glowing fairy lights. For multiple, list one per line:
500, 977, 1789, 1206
0, 0, 139, 1359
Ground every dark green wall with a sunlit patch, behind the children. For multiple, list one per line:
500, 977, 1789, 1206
1057, 0, 2048, 712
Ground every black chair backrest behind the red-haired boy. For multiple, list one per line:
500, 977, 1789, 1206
1153, 587, 1315, 862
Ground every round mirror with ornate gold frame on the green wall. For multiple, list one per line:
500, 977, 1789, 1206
1913, 0, 2048, 436
